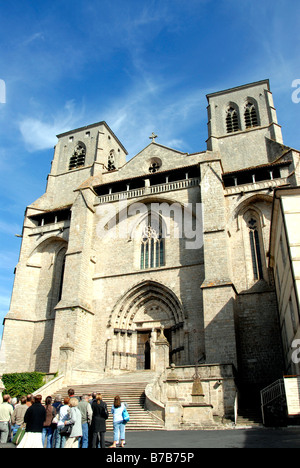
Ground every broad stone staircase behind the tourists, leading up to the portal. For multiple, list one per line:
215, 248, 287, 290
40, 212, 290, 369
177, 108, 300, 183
53, 373, 164, 432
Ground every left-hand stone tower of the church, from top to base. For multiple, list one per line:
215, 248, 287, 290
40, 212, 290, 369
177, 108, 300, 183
3, 122, 127, 372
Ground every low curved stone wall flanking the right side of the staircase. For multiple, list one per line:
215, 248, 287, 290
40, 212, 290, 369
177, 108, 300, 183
146, 364, 237, 430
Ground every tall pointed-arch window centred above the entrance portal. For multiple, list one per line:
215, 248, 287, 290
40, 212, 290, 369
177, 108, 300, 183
140, 215, 165, 270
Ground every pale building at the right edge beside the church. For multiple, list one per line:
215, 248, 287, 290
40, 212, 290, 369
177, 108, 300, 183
269, 186, 300, 375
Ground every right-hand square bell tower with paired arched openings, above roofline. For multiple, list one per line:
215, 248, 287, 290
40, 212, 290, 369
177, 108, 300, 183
207, 80, 282, 172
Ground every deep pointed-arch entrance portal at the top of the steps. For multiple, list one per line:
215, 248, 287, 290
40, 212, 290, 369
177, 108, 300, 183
106, 281, 188, 371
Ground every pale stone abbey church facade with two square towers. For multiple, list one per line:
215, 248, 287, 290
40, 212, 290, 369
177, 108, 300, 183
1, 80, 300, 418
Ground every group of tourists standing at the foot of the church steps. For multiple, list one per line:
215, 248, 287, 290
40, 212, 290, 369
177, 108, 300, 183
0, 389, 127, 448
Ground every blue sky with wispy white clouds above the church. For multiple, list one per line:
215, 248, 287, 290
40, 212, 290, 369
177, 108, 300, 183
0, 0, 300, 336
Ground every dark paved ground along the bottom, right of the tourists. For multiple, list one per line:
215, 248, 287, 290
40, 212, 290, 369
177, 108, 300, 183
0, 426, 300, 453
